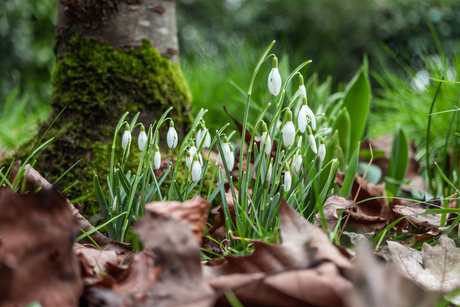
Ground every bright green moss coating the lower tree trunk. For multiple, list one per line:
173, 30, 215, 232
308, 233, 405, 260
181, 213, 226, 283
5, 35, 191, 224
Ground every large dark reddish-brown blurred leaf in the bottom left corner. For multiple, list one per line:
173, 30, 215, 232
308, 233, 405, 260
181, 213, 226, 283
0, 189, 83, 306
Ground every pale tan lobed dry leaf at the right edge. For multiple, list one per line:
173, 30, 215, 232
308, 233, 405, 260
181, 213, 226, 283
388, 234, 460, 304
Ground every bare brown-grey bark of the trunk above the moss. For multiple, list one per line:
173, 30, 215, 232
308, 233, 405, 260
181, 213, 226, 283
57, 0, 178, 62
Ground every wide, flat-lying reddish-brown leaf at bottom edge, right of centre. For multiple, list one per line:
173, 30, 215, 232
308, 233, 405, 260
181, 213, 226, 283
209, 262, 351, 307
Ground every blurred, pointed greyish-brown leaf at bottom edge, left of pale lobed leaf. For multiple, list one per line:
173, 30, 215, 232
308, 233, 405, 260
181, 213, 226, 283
346, 244, 439, 307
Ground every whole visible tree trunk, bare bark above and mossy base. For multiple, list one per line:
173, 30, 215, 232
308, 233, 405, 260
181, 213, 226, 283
21, 0, 191, 207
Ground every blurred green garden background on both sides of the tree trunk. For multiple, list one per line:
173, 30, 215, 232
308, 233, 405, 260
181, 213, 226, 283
0, 0, 460, 154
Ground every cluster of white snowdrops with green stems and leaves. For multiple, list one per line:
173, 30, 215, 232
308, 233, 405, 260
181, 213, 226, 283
94, 42, 330, 248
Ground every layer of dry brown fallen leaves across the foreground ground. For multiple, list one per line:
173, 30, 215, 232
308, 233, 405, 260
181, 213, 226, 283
0, 167, 459, 307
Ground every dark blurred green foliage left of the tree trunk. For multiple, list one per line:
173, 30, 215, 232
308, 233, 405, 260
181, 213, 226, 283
0, 0, 57, 110
